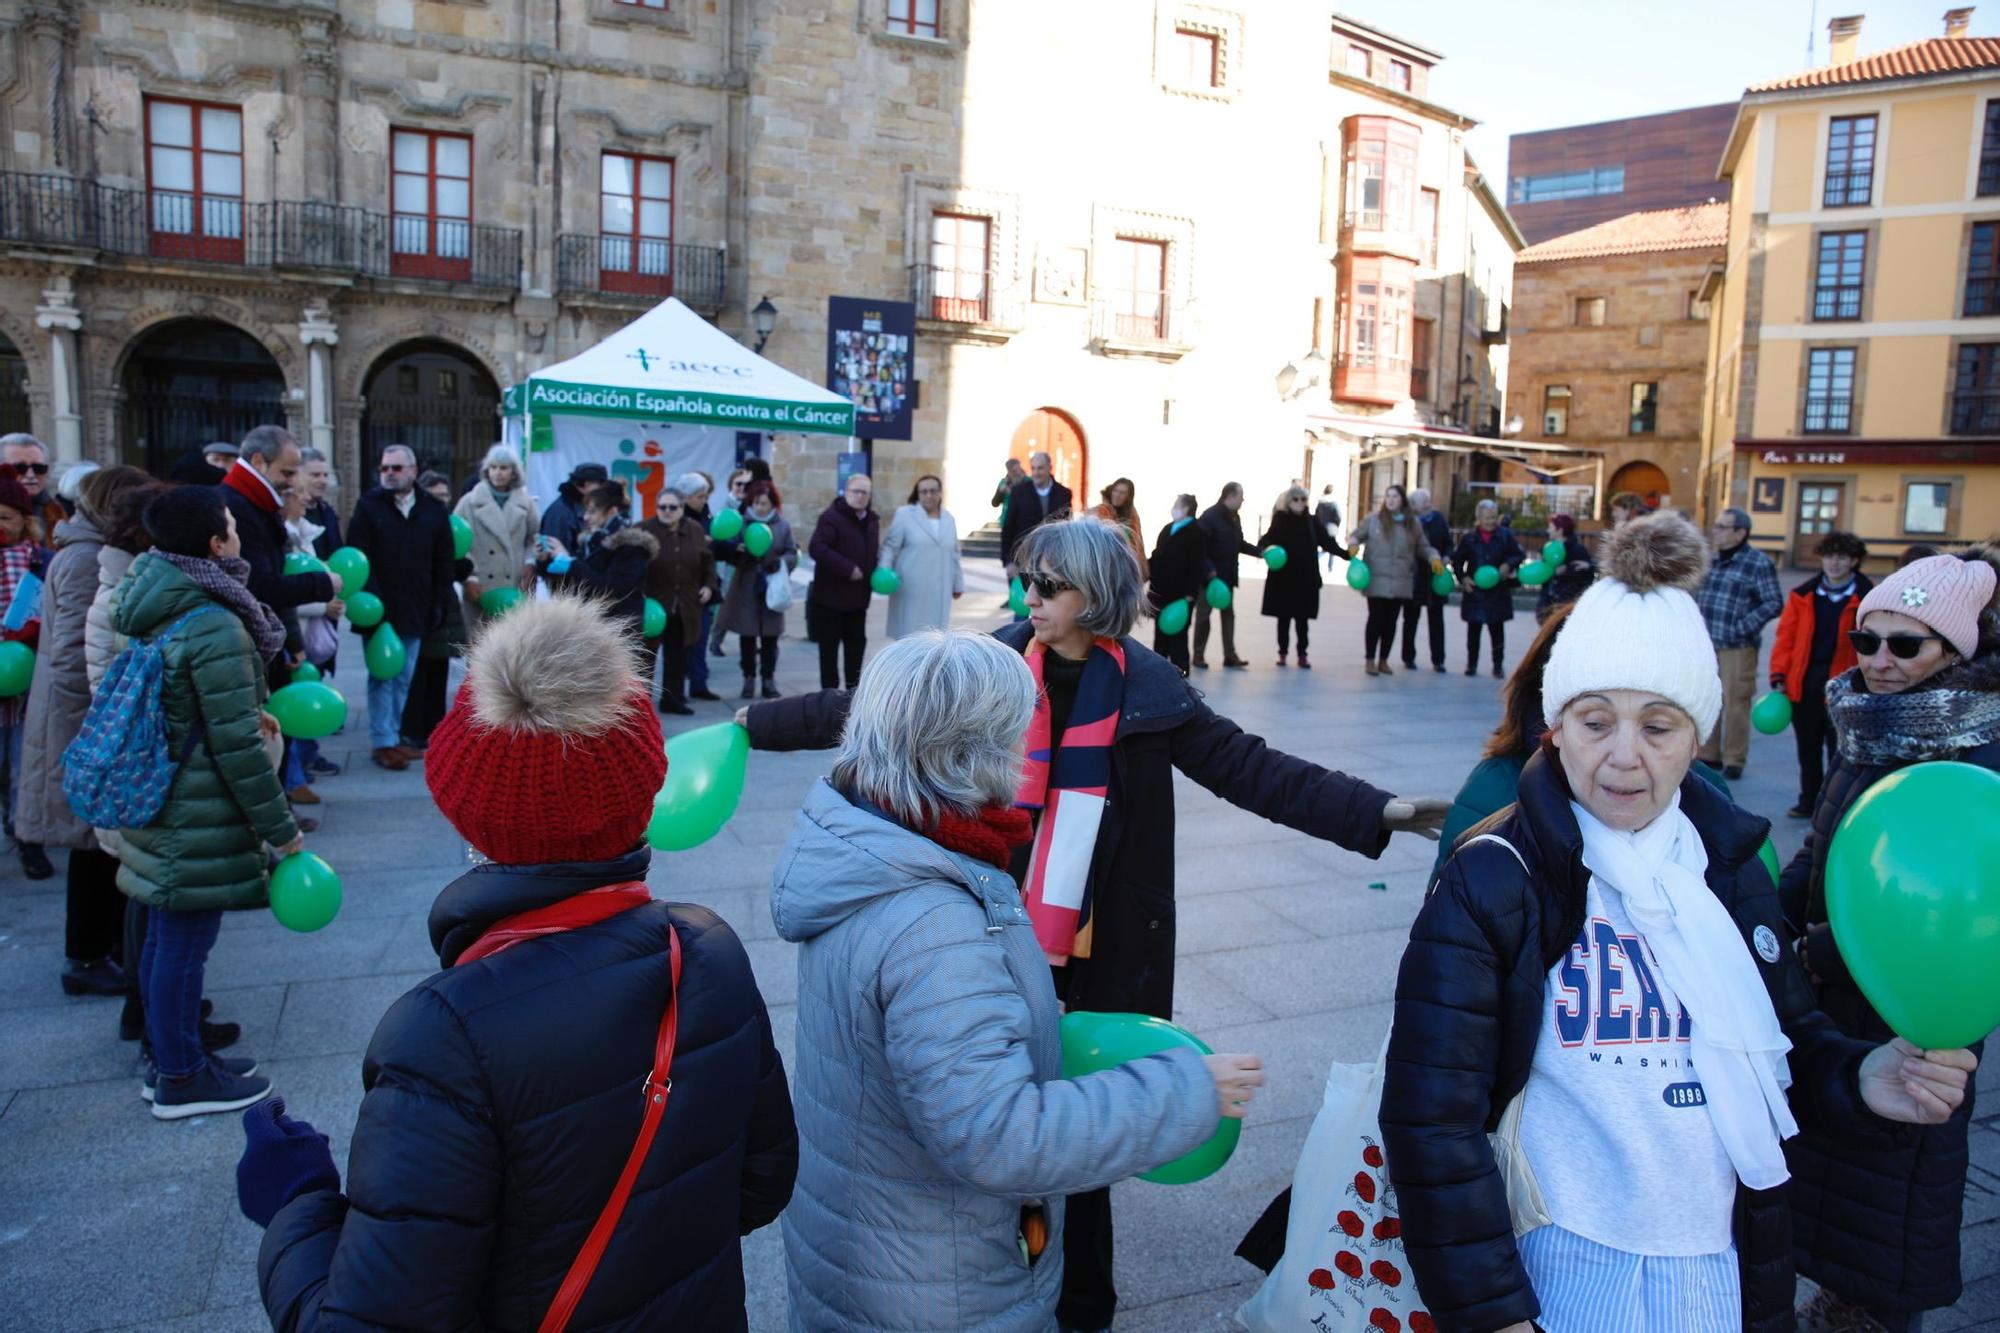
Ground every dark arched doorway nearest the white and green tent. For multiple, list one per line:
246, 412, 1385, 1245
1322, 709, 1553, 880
362, 338, 500, 494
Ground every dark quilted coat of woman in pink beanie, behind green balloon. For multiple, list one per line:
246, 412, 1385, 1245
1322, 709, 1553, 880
1778, 656, 2000, 1313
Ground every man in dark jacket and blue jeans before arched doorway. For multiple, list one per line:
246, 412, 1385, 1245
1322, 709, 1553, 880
348, 444, 452, 769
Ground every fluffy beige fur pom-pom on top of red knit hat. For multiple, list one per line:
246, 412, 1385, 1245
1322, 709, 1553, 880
466, 594, 640, 737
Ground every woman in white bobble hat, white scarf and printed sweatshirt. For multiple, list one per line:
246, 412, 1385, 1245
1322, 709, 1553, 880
1380, 514, 1976, 1333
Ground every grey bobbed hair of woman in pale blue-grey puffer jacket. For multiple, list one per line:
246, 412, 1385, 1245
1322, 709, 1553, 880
832, 628, 1046, 829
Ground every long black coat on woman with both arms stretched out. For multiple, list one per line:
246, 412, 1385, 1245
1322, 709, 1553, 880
748, 620, 1390, 1019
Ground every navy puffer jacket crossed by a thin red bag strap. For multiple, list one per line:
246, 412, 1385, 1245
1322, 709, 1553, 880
258, 849, 798, 1331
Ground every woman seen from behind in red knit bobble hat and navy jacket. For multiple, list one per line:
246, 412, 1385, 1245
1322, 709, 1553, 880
238, 596, 798, 1329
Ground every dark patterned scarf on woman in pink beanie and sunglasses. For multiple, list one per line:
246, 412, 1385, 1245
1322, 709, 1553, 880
1826, 654, 2000, 765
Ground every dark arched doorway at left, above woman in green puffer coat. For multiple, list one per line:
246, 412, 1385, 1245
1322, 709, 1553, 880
120, 320, 286, 476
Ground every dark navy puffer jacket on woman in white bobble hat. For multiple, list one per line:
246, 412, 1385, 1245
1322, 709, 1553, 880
1382, 753, 1896, 1333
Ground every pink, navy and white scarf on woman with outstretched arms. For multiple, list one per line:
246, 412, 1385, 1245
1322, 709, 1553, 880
1014, 638, 1124, 967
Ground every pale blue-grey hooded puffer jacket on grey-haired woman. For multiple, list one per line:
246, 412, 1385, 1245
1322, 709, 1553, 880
770, 781, 1216, 1333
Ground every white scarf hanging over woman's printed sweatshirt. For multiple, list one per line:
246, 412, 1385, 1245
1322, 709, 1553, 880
1570, 793, 1798, 1189
